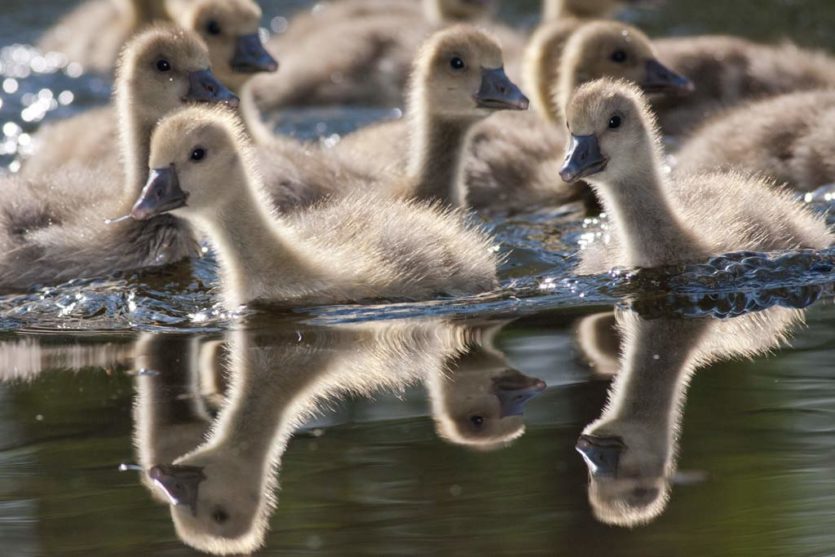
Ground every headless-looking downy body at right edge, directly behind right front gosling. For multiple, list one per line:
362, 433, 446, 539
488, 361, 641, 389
675, 90, 835, 192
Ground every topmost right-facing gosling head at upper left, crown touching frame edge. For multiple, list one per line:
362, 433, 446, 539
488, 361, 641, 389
175, 0, 278, 91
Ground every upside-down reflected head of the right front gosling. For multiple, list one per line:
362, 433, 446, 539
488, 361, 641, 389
577, 422, 672, 527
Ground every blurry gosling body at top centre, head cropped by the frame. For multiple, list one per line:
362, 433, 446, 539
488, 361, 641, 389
254, 0, 524, 111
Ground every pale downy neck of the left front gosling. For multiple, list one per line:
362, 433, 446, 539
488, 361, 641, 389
183, 163, 325, 310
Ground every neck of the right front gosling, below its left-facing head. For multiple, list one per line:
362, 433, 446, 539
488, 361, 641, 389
588, 153, 707, 267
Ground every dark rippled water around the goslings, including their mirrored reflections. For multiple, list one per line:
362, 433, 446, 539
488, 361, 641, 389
0, 0, 835, 556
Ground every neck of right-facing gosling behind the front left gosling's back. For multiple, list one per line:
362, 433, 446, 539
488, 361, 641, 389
409, 109, 476, 206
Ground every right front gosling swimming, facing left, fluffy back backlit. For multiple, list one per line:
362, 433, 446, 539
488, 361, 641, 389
560, 79, 833, 273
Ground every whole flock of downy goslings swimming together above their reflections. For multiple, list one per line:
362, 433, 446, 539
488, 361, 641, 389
0, 0, 835, 311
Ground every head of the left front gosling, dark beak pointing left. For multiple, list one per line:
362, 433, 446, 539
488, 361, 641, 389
131, 107, 253, 220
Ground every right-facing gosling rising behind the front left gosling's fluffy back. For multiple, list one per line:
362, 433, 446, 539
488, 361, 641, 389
337, 26, 528, 205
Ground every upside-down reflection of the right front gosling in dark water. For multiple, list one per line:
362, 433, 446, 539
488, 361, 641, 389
577, 300, 804, 527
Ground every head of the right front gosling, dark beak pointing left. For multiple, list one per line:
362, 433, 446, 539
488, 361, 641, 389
560, 79, 661, 185
